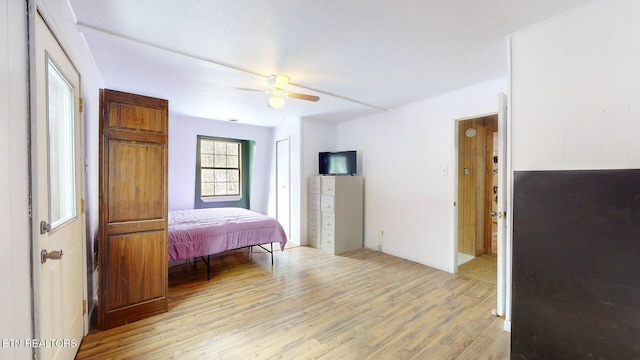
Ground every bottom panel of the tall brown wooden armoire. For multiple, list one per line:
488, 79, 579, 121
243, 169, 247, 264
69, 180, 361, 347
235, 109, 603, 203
106, 230, 167, 311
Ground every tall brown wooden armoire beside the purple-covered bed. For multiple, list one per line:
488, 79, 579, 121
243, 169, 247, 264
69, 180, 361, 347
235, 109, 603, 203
98, 89, 168, 329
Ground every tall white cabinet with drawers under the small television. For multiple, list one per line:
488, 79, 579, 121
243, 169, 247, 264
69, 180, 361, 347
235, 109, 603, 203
308, 176, 364, 254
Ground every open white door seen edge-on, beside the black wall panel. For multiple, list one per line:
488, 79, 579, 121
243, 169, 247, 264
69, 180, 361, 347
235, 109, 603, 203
496, 93, 509, 316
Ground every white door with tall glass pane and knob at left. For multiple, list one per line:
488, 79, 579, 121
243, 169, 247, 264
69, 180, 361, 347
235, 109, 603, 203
31, 15, 85, 359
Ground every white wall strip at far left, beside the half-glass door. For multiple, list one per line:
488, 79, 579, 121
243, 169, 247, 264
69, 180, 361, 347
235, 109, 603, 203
0, 0, 33, 359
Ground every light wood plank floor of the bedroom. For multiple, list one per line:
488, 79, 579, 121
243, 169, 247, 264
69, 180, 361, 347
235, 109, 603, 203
77, 247, 510, 360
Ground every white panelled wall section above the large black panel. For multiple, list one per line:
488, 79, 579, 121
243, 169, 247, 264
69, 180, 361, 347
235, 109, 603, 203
511, 0, 640, 170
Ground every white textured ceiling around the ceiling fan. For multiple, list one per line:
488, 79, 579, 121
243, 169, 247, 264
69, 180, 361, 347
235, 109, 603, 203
68, 0, 590, 126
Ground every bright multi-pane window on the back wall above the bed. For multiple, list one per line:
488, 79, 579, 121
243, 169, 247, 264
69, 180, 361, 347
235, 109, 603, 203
198, 137, 242, 200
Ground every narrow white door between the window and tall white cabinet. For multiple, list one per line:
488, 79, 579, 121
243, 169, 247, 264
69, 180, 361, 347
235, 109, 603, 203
276, 139, 291, 239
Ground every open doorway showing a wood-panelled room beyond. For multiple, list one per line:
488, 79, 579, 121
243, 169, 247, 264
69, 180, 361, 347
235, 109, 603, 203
457, 114, 499, 283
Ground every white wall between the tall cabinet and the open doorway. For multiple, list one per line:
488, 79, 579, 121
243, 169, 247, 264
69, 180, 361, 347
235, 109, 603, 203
337, 77, 506, 272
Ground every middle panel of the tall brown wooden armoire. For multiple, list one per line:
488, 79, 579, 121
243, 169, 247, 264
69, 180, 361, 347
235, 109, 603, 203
108, 139, 166, 224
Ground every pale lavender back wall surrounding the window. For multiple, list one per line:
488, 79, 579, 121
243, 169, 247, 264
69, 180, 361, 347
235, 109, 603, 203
169, 114, 275, 215
